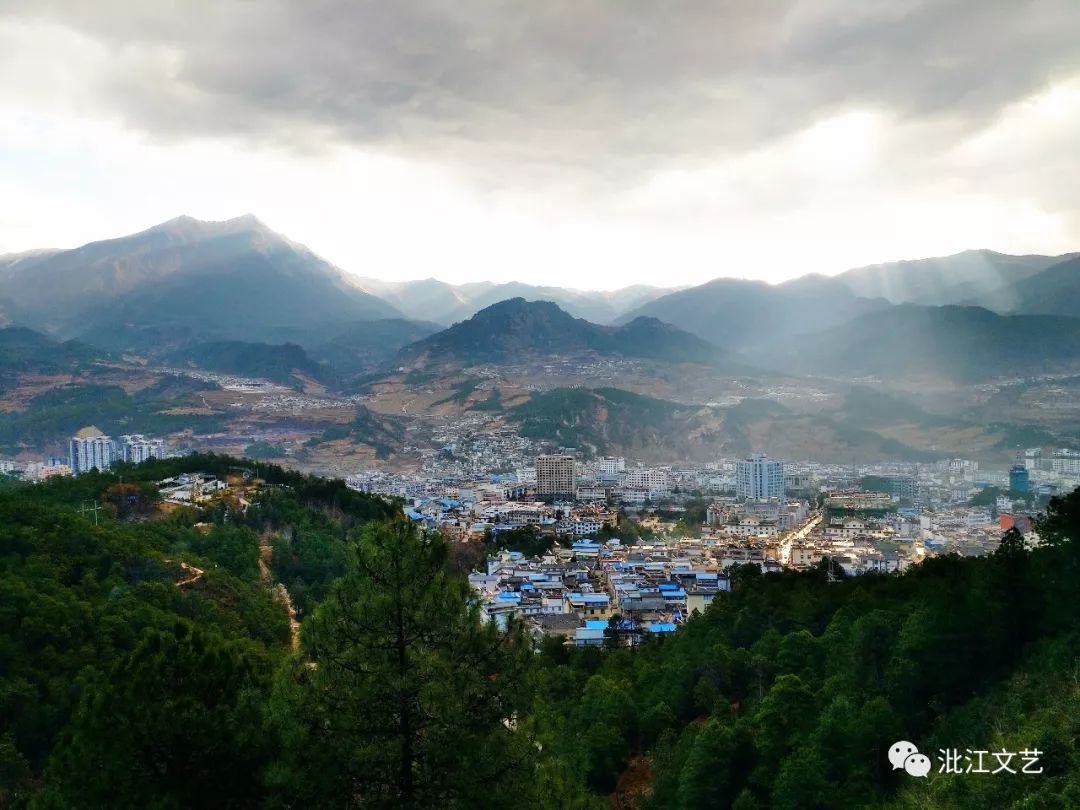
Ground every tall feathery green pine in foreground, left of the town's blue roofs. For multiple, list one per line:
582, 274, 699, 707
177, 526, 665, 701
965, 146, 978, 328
271, 521, 534, 808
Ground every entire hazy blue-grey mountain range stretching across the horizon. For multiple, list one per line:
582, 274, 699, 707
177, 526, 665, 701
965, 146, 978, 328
0, 215, 1080, 379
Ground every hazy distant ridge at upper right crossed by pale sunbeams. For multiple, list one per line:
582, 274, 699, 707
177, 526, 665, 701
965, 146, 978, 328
836, 251, 1065, 309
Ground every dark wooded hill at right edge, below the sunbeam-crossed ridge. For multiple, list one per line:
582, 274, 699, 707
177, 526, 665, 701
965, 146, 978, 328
772, 305, 1080, 382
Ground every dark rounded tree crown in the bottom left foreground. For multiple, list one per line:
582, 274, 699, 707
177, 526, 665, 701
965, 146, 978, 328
43, 622, 270, 808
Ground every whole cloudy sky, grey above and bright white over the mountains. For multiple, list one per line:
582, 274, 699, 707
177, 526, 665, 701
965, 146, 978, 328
0, 0, 1080, 289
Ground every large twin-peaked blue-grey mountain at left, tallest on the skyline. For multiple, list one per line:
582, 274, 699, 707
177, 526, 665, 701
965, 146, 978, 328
0, 216, 399, 350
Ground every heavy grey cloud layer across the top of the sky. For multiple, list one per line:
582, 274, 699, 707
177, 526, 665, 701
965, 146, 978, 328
0, 0, 1080, 181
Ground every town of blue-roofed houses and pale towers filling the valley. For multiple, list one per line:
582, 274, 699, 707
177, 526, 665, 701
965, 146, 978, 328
0, 427, 1080, 646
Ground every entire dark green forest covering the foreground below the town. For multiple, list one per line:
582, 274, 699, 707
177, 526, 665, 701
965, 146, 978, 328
0, 456, 1080, 810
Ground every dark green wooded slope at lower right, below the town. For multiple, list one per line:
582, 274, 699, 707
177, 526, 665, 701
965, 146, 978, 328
534, 490, 1080, 809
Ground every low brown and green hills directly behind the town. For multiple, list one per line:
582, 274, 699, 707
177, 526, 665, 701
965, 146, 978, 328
505, 388, 1053, 464
